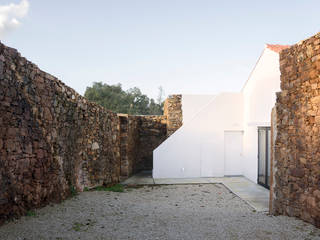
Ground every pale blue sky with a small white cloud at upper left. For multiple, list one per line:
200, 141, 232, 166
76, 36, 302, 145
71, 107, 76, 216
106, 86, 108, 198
0, 0, 320, 98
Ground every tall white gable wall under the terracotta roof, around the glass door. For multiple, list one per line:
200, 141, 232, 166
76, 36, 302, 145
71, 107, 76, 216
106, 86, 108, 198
242, 48, 280, 182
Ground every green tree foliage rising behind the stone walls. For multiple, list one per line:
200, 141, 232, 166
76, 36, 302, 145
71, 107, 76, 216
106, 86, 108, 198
84, 82, 164, 115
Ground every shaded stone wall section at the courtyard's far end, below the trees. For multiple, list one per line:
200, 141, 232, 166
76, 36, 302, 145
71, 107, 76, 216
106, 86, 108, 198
119, 114, 167, 178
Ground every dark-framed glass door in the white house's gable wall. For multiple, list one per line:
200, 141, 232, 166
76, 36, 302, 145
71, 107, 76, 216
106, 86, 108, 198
258, 127, 271, 189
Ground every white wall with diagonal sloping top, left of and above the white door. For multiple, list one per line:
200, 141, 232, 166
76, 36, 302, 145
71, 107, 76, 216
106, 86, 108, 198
153, 93, 243, 178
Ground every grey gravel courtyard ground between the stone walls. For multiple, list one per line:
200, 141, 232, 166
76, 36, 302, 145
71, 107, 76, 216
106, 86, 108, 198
0, 184, 320, 240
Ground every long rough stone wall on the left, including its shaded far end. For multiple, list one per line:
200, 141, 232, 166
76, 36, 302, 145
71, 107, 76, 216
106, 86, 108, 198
0, 43, 182, 223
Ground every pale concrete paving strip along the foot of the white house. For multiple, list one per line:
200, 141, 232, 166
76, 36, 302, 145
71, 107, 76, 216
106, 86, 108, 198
122, 171, 269, 212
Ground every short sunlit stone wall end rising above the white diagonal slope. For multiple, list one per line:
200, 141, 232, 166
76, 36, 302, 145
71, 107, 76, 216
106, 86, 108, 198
163, 95, 182, 136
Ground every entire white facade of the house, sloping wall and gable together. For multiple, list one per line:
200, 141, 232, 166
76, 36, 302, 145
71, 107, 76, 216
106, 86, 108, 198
153, 44, 280, 182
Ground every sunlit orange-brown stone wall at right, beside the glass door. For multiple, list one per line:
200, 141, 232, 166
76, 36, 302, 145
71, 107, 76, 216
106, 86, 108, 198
272, 33, 320, 227
